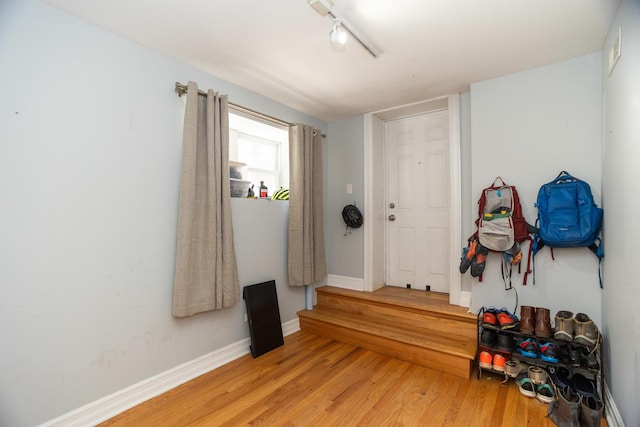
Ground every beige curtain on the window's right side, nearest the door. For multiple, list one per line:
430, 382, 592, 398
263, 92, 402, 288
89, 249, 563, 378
288, 124, 327, 286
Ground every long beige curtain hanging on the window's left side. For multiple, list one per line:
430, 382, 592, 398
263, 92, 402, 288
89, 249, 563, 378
173, 82, 240, 317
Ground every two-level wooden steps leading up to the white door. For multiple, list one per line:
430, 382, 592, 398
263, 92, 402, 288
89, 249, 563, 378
298, 286, 477, 378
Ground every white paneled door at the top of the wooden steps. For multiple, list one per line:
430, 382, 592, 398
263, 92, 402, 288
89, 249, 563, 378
385, 111, 451, 293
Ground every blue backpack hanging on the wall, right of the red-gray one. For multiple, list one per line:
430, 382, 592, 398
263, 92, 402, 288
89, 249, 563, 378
532, 171, 604, 287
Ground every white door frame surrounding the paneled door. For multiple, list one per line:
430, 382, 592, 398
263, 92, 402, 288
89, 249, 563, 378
363, 94, 471, 307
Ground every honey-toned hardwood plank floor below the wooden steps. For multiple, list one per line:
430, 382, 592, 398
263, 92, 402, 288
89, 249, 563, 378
102, 332, 604, 427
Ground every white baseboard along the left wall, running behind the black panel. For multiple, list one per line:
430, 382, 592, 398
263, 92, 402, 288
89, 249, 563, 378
41, 317, 300, 427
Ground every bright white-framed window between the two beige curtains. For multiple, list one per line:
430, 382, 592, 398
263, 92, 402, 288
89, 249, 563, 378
229, 112, 289, 196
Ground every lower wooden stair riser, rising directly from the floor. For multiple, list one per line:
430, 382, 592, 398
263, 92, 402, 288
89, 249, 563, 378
300, 316, 473, 378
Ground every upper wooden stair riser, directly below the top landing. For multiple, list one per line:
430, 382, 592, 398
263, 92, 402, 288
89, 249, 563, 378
317, 292, 477, 339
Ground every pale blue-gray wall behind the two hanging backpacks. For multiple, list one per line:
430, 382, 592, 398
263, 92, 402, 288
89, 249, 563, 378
467, 53, 602, 325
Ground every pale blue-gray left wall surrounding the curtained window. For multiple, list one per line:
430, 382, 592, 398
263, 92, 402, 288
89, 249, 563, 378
0, 0, 327, 426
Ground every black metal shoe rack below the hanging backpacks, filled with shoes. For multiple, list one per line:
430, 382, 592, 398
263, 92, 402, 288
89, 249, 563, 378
476, 307, 604, 402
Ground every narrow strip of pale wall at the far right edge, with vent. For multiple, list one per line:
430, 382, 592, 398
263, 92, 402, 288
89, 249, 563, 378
602, 0, 640, 427
